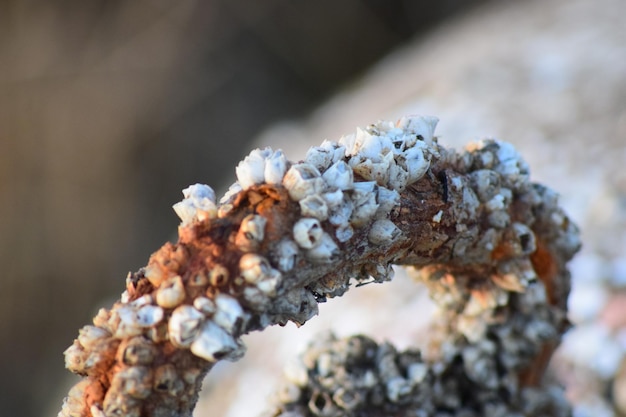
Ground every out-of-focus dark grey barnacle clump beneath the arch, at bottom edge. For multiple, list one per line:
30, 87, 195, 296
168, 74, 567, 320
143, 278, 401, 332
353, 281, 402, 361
266, 334, 571, 417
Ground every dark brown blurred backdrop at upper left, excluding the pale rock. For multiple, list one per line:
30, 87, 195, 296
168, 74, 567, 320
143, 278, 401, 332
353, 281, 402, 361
0, 0, 492, 417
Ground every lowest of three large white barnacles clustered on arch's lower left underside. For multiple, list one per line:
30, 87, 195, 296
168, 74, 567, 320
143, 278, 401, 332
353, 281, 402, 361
191, 320, 245, 362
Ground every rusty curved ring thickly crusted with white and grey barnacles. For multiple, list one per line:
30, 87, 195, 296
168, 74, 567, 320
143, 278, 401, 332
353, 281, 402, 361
59, 117, 579, 417
